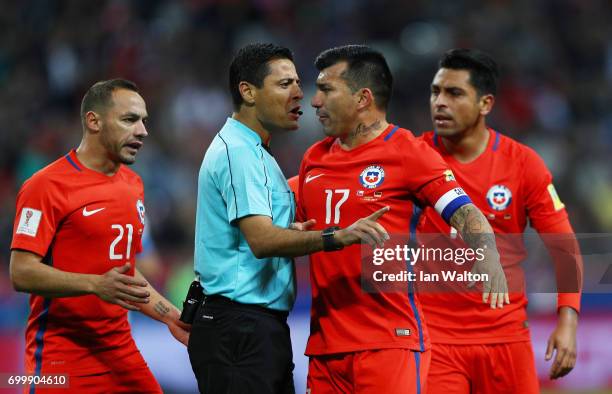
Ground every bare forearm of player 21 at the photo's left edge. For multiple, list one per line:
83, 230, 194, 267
10, 250, 95, 298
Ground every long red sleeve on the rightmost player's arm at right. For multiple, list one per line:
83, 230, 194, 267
523, 148, 584, 312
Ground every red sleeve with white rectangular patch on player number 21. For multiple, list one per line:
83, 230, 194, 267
11, 175, 65, 257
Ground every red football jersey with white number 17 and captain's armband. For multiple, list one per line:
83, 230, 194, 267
299, 125, 469, 355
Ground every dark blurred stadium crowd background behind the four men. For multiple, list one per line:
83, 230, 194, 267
0, 0, 612, 393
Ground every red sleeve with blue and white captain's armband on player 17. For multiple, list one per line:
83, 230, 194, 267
402, 139, 471, 223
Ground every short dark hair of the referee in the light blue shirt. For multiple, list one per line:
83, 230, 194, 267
229, 43, 293, 110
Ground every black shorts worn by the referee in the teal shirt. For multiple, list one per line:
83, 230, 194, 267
187, 296, 295, 394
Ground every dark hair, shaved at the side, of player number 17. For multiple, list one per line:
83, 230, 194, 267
315, 45, 393, 110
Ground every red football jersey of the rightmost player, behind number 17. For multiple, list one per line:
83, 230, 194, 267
418, 130, 582, 344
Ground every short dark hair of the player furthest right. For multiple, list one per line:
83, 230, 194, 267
438, 48, 499, 96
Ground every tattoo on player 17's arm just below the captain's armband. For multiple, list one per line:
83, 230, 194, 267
450, 204, 496, 250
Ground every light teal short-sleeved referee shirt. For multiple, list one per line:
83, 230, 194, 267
194, 118, 295, 311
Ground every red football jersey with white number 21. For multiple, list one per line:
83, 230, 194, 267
11, 150, 144, 375
